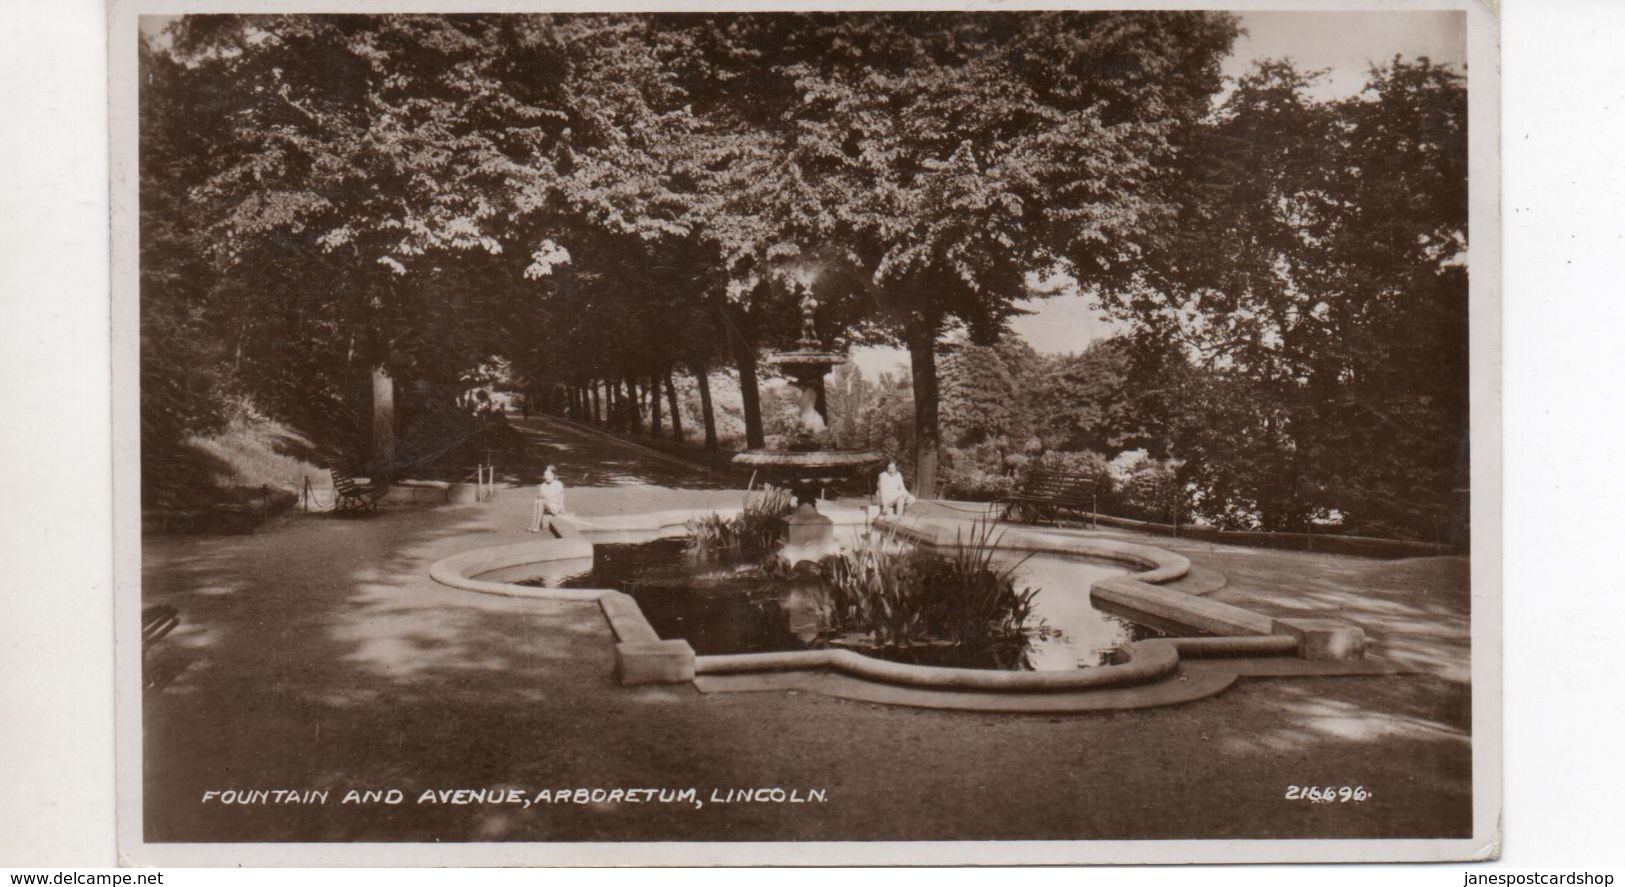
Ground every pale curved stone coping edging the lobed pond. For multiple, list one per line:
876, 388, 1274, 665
429, 508, 1363, 694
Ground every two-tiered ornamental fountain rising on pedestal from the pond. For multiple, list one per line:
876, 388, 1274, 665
733, 281, 884, 564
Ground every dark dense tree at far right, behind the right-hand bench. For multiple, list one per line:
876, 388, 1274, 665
1108, 58, 1467, 536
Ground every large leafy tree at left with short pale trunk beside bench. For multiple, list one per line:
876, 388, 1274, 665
160, 16, 578, 469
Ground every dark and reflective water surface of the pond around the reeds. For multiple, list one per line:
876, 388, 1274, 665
522, 539, 1157, 671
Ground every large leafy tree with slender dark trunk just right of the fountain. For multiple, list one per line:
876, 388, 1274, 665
767, 13, 1235, 495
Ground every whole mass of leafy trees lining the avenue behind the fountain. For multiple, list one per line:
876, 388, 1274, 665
140, 11, 1467, 538
